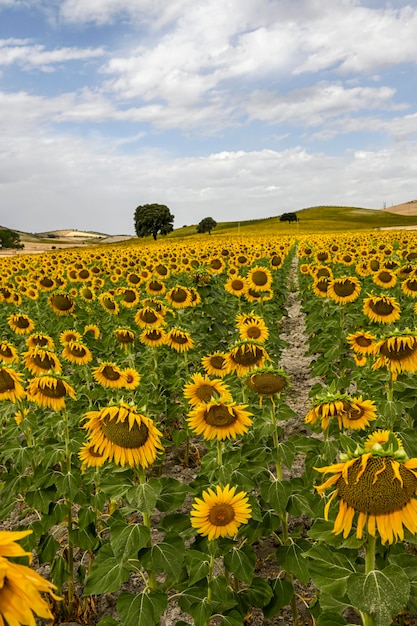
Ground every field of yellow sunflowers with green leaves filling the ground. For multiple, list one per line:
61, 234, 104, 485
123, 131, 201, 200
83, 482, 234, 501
0, 231, 417, 626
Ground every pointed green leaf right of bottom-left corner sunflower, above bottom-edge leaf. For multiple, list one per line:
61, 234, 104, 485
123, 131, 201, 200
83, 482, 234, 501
84, 543, 130, 595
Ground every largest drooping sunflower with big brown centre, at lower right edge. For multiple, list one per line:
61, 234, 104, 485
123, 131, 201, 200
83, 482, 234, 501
315, 438, 417, 544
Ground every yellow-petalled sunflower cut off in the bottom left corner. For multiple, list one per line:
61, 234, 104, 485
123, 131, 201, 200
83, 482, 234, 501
0, 530, 61, 626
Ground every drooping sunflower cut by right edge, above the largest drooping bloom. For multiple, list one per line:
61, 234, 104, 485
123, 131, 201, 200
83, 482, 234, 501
372, 329, 417, 380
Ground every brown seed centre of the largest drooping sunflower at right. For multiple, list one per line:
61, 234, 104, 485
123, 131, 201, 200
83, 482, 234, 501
337, 457, 417, 515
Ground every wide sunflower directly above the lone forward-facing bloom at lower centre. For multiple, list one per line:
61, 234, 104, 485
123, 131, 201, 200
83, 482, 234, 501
187, 398, 252, 441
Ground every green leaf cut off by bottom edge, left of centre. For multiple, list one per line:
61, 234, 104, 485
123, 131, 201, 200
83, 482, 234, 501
117, 591, 168, 626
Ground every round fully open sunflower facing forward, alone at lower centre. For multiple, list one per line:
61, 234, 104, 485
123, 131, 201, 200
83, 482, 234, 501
190, 485, 252, 541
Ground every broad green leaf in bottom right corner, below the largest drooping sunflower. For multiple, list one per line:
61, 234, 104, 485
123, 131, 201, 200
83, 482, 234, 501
348, 565, 410, 626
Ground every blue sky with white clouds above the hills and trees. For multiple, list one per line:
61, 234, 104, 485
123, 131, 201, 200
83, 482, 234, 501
0, 0, 417, 234
